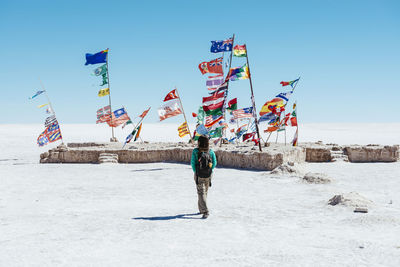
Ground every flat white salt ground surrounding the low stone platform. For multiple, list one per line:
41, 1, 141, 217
0, 125, 400, 266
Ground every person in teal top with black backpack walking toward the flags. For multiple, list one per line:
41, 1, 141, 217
191, 136, 217, 219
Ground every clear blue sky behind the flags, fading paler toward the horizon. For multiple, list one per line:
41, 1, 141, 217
0, 0, 400, 123
